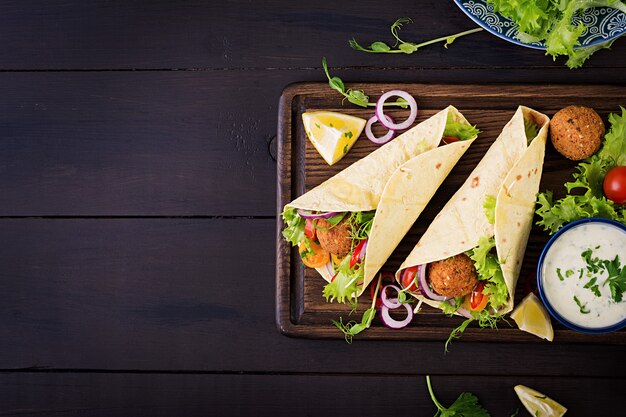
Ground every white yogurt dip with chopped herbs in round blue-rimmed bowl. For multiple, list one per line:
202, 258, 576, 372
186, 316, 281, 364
539, 221, 626, 330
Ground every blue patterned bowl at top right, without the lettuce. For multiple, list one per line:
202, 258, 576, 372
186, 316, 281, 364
454, 0, 626, 50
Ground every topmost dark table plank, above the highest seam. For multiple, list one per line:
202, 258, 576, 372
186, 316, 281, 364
0, 0, 626, 70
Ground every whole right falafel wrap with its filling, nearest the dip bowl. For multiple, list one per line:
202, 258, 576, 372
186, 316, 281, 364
396, 106, 550, 320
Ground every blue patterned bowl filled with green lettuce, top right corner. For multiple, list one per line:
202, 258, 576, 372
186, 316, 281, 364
454, 0, 626, 68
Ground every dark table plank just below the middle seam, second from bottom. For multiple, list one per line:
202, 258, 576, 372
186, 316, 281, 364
0, 219, 626, 376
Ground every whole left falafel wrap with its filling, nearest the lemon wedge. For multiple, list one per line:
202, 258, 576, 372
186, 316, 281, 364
282, 106, 478, 303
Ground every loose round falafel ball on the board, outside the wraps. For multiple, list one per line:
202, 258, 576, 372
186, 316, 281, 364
550, 106, 605, 161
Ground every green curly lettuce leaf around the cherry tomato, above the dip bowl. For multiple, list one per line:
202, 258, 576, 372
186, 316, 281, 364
535, 107, 626, 234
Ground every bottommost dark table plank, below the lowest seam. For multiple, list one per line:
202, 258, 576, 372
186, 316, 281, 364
0, 373, 624, 417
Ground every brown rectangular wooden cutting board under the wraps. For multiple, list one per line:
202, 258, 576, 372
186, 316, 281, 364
276, 83, 626, 344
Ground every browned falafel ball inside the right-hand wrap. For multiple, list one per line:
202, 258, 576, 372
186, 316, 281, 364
428, 253, 478, 298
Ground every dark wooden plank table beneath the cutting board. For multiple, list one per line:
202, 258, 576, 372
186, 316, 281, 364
0, 0, 626, 417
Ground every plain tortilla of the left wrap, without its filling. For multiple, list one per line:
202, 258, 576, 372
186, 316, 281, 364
285, 106, 475, 296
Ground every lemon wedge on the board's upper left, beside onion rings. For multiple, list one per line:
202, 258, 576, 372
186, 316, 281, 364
302, 111, 366, 165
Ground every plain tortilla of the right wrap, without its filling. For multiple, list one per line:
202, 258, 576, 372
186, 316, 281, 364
396, 106, 550, 314
